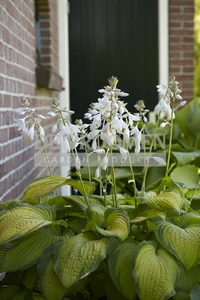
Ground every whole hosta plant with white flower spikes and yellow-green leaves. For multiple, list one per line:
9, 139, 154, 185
0, 77, 200, 300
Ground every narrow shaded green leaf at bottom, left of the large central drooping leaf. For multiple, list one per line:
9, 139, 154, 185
38, 253, 67, 300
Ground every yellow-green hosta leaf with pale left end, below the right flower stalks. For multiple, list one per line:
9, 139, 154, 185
139, 191, 183, 215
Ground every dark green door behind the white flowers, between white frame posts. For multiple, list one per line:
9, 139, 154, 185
69, 0, 158, 119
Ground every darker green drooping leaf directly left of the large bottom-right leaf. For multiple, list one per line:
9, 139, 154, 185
108, 240, 137, 300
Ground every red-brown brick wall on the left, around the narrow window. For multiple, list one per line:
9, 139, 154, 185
0, 0, 58, 201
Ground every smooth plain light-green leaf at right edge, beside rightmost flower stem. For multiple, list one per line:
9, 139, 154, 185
170, 165, 199, 189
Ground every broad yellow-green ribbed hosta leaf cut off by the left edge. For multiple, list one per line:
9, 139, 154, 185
0, 202, 55, 244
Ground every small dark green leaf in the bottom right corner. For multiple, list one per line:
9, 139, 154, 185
176, 265, 200, 293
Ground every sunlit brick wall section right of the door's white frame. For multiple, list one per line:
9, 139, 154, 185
169, 0, 194, 101
